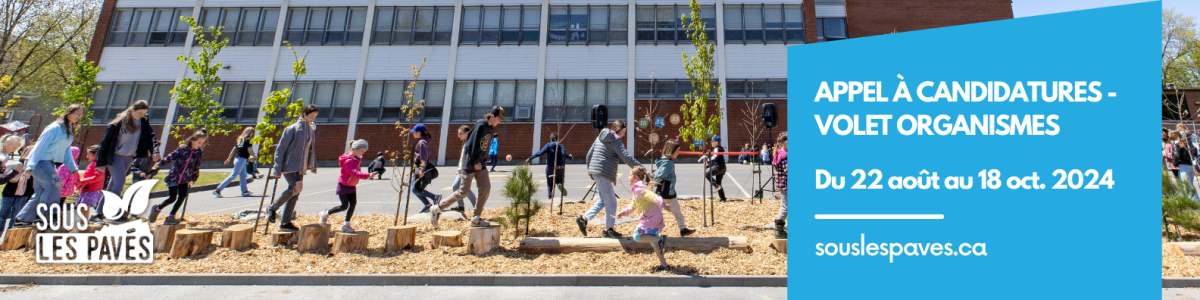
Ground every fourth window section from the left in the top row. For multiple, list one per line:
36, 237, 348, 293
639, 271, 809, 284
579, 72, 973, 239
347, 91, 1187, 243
371, 6, 454, 44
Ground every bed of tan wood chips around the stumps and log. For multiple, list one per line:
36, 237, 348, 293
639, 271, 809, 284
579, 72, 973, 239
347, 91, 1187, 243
0, 195, 787, 276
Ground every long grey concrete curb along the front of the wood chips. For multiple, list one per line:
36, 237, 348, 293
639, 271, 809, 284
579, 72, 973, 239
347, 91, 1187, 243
0, 274, 787, 288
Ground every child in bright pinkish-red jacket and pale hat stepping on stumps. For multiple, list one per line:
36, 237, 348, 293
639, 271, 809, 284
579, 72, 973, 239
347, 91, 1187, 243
320, 139, 371, 233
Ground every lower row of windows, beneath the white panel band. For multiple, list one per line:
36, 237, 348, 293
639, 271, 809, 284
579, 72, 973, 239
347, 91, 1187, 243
91, 79, 787, 124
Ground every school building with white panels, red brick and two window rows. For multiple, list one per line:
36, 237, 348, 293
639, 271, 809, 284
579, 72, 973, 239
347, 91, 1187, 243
79, 0, 1013, 163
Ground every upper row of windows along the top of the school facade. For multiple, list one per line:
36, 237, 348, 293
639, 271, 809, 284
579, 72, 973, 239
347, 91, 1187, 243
106, 5, 847, 47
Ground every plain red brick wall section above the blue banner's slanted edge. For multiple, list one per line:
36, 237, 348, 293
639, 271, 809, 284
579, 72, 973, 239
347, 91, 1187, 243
846, 0, 1013, 37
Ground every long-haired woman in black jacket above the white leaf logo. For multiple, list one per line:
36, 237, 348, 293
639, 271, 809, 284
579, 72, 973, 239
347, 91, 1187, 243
96, 100, 160, 221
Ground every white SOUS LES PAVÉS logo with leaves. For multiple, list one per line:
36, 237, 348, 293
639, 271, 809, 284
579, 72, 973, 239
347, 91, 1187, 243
35, 180, 158, 264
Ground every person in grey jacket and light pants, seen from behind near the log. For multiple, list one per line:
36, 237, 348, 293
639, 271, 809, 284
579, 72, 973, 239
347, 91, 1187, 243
575, 120, 642, 239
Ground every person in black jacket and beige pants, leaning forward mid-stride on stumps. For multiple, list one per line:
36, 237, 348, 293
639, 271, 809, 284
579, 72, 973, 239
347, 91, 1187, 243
430, 107, 504, 229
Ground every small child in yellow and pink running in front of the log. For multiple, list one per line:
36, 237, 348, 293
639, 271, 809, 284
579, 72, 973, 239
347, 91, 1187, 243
617, 166, 671, 272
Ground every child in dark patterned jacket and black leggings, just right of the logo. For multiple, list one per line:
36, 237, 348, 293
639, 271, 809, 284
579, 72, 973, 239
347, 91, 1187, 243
150, 130, 209, 224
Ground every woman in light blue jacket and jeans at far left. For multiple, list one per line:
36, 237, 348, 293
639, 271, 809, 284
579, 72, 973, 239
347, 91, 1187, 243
17, 104, 84, 224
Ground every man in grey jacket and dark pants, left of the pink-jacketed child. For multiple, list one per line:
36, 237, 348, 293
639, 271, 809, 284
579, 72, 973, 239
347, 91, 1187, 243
266, 104, 317, 230
